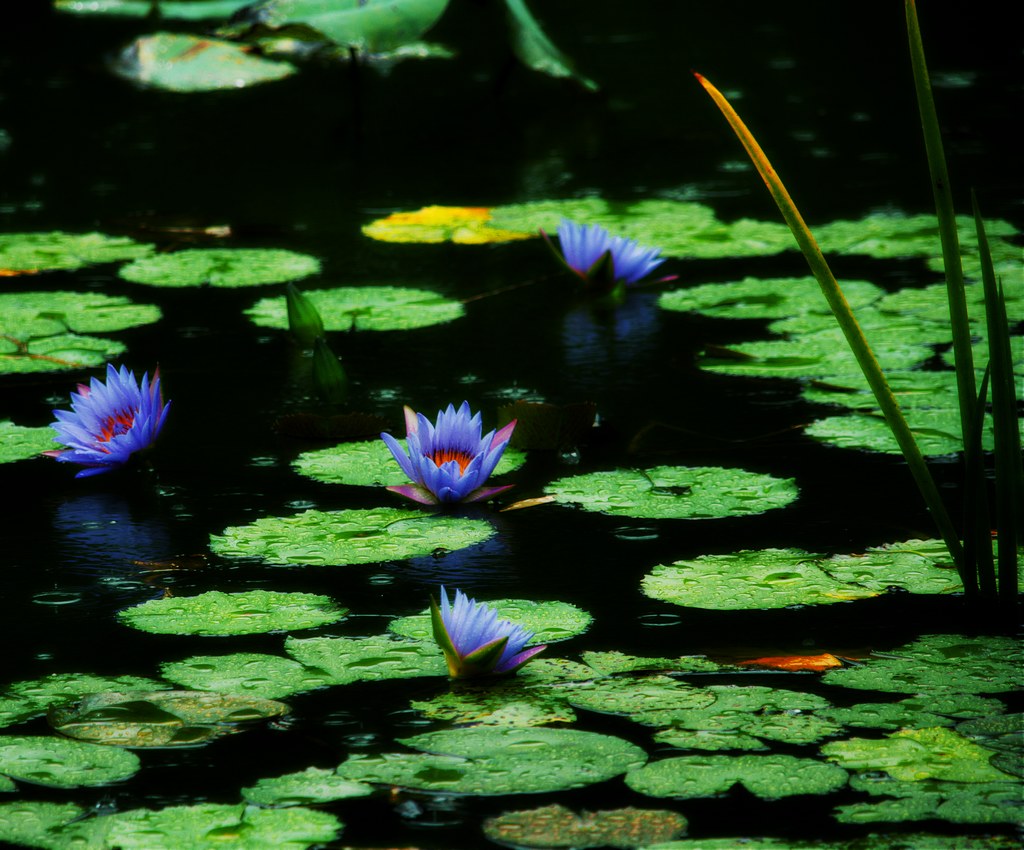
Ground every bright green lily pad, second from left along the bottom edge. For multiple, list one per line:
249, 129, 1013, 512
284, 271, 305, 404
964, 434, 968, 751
110, 803, 342, 850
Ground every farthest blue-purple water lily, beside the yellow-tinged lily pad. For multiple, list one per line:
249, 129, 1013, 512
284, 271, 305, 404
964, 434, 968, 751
541, 218, 665, 290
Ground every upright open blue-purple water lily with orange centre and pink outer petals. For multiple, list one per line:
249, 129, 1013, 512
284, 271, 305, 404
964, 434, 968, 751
381, 401, 515, 505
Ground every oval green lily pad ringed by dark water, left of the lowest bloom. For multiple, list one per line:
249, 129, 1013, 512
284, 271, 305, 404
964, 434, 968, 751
119, 590, 348, 635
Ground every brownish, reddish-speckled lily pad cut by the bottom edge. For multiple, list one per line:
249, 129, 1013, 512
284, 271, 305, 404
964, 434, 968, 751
483, 804, 687, 850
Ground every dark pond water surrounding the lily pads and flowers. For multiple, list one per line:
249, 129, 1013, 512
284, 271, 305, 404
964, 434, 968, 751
0, 0, 1024, 848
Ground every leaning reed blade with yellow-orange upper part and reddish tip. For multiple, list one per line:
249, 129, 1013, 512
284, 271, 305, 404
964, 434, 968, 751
694, 74, 973, 588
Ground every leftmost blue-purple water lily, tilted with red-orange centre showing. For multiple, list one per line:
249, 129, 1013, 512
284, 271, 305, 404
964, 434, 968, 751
43, 364, 171, 478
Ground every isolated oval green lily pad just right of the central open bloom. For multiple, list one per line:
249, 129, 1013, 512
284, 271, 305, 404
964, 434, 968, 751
544, 466, 797, 519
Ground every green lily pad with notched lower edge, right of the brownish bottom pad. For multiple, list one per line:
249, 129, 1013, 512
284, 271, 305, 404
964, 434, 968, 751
626, 754, 847, 800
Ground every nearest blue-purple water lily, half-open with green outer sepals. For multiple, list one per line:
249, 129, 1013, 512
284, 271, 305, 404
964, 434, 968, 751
430, 587, 547, 679
